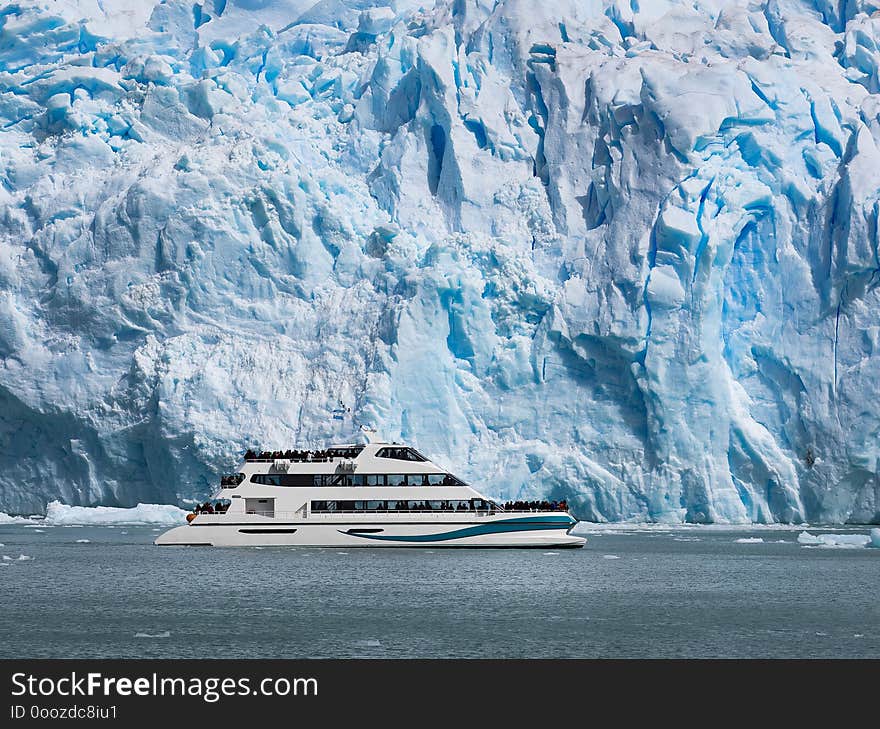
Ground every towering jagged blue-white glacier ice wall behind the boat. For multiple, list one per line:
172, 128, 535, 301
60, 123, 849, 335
0, 0, 880, 522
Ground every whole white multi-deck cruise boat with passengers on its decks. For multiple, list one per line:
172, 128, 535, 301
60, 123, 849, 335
156, 443, 586, 548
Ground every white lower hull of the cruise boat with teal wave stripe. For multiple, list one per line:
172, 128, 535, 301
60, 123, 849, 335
155, 515, 586, 549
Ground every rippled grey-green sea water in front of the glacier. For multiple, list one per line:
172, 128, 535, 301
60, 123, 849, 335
0, 525, 880, 658
